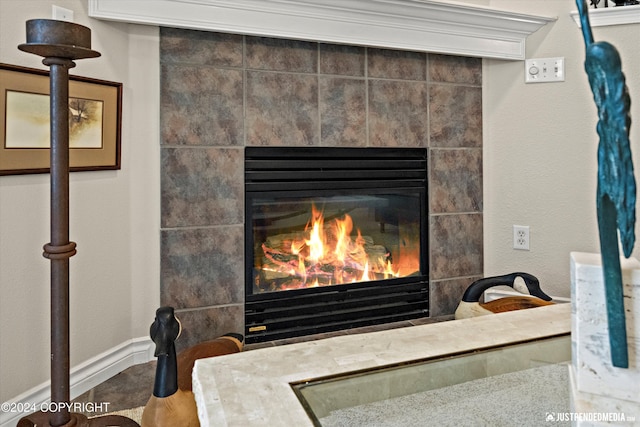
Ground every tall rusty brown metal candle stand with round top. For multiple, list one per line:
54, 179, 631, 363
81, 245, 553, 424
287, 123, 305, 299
18, 19, 138, 427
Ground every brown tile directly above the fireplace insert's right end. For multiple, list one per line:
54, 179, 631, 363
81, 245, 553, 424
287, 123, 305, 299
369, 80, 428, 147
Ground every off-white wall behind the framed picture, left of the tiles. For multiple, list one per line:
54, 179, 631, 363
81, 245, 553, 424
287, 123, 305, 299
0, 0, 160, 401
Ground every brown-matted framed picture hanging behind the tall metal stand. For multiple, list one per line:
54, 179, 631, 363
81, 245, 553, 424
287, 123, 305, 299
0, 64, 122, 175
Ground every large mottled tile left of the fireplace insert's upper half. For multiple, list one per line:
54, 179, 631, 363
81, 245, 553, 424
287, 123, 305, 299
160, 147, 244, 228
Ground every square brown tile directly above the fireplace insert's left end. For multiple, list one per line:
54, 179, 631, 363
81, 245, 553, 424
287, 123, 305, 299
246, 71, 320, 146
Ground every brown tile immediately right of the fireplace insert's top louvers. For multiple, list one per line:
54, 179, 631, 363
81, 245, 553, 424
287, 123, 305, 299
429, 148, 482, 213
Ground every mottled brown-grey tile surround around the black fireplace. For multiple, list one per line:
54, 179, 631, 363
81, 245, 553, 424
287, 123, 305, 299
160, 28, 483, 349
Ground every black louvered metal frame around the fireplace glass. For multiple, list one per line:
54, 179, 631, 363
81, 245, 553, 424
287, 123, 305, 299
245, 147, 429, 343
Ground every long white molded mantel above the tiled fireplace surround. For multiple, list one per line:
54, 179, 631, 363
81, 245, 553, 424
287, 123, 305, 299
89, 0, 556, 60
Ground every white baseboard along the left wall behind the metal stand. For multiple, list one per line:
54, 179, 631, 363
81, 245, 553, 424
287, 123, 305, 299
0, 337, 155, 427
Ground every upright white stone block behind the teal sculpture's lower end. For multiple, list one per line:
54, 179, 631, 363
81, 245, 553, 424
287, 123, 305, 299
571, 252, 640, 402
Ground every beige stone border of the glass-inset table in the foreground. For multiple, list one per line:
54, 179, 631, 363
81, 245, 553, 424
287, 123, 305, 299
193, 304, 571, 427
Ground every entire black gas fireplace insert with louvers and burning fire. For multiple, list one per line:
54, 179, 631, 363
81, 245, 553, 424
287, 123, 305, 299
245, 147, 429, 343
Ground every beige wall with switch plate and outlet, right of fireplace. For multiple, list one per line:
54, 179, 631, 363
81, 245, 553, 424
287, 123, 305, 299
483, 0, 640, 296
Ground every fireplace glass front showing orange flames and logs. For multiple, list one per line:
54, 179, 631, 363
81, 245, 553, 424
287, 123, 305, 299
251, 192, 421, 294
